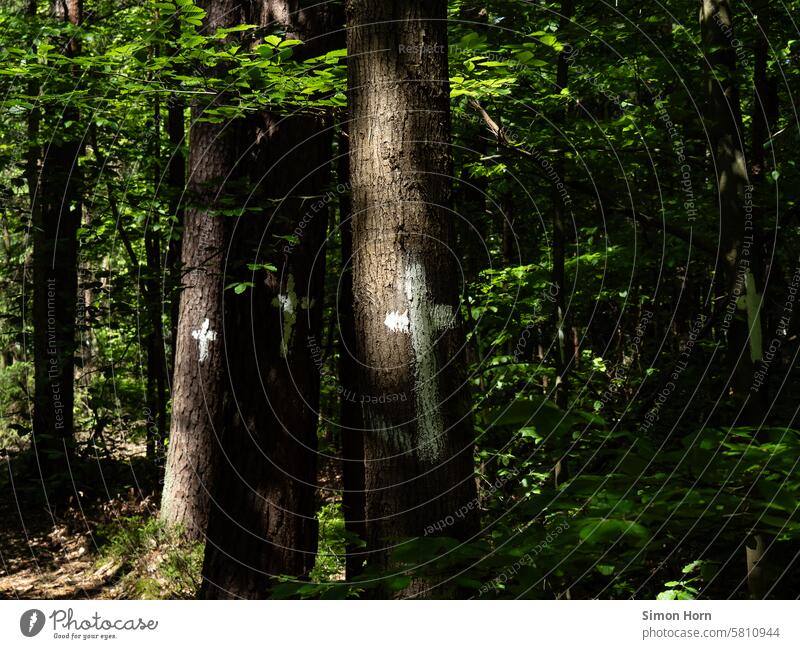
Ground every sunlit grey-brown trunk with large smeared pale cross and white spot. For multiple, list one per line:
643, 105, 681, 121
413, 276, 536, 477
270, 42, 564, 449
347, 0, 476, 596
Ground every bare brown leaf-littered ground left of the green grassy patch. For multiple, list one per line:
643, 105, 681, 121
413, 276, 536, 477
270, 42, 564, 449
0, 436, 154, 599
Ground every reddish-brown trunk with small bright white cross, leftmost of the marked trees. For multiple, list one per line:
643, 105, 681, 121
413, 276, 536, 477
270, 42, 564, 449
156, 0, 244, 540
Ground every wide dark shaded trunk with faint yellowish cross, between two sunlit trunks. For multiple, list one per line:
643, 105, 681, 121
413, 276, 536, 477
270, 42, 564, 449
201, 0, 334, 599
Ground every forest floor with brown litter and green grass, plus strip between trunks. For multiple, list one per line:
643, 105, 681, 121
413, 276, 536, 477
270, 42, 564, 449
0, 442, 344, 600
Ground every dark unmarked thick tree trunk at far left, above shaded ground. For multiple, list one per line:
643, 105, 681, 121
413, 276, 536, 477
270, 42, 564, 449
33, 0, 83, 486
